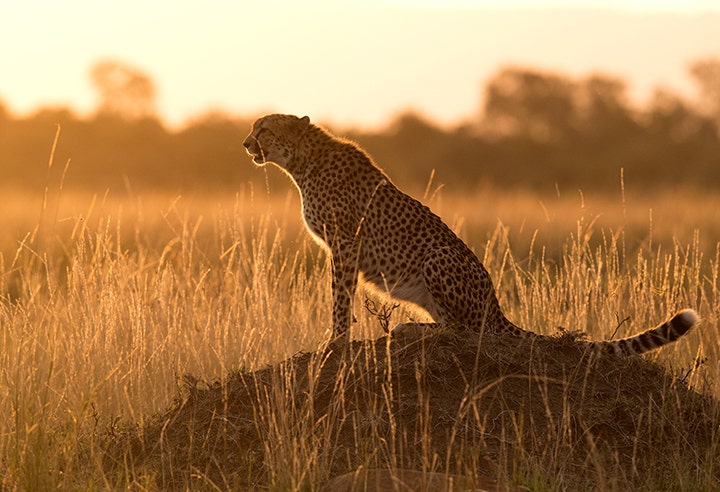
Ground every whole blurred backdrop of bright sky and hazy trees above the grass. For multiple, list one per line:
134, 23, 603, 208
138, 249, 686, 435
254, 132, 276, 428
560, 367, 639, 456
0, 0, 720, 211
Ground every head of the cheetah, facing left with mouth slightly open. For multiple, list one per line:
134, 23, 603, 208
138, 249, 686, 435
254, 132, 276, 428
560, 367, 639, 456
243, 114, 310, 168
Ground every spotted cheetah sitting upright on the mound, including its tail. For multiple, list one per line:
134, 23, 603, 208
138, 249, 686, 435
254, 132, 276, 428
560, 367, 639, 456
243, 114, 698, 355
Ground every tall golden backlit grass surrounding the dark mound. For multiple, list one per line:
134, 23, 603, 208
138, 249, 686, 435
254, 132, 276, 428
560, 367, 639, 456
0, 187, 720, 490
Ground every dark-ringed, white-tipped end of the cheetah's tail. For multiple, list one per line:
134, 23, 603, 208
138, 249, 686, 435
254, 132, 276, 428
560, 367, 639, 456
588, 309, 700, 355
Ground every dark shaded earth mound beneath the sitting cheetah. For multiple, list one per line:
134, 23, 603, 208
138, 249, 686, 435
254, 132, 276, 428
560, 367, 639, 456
106, 333, 720, 490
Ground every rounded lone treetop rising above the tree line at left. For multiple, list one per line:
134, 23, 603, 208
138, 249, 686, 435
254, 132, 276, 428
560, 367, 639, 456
90, 60, 155, 120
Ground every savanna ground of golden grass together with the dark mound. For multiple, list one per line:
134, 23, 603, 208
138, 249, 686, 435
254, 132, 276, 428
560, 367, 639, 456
0, 172, 720, 490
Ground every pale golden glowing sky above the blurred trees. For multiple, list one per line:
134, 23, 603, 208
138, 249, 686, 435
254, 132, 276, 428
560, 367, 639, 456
0, 0, 720, 126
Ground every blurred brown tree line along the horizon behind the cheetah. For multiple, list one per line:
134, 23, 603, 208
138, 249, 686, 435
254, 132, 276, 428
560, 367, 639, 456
0, 59, 720, 193
